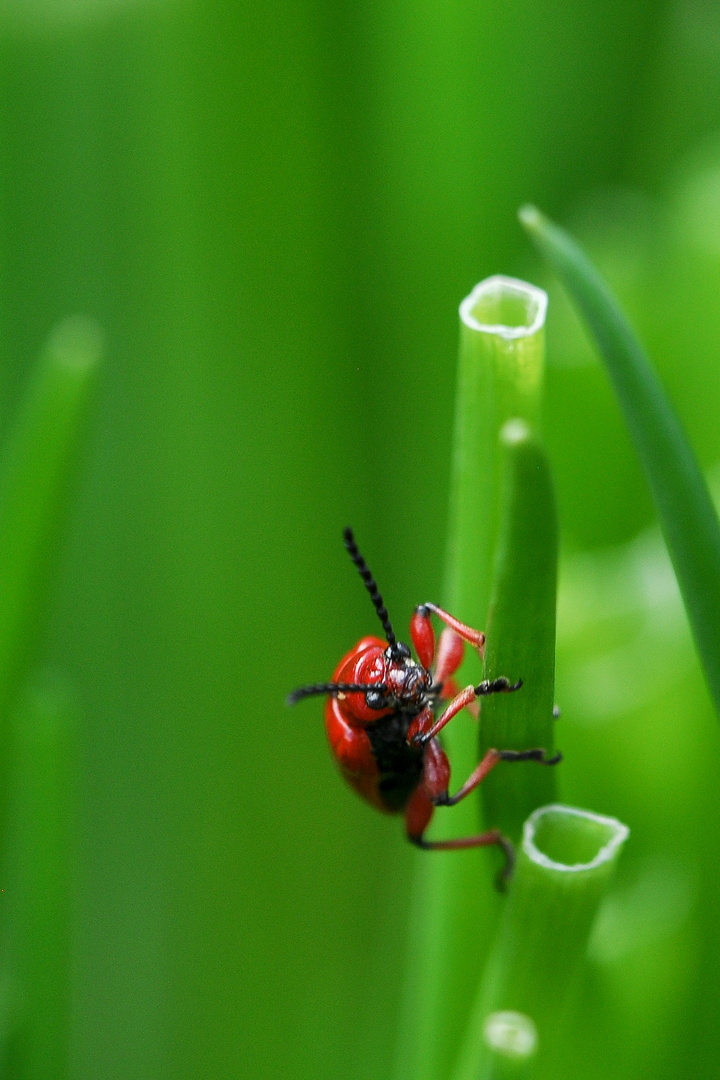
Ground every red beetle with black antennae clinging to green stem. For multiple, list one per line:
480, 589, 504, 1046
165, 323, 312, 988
288, 528, 561, 876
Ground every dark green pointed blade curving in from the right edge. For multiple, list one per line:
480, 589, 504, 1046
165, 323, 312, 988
520, 206, 720, 715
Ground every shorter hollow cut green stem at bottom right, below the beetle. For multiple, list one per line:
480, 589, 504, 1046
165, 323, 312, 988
453, 806, 628, 1080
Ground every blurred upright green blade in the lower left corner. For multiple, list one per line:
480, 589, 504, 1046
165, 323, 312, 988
3, 687, 76, 1080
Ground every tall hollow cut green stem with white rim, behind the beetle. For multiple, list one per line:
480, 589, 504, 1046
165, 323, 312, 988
395, 276, 547, 1080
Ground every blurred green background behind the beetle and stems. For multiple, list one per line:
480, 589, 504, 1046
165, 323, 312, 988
0, 0, 720, 1080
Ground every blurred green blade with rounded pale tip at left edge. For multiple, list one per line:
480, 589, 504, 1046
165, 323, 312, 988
0, 318, 100, 726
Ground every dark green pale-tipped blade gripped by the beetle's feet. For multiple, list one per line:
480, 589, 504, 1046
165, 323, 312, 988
480, 420, 558, 840
